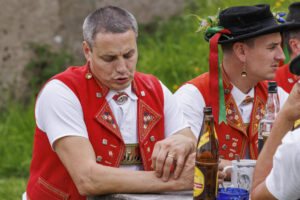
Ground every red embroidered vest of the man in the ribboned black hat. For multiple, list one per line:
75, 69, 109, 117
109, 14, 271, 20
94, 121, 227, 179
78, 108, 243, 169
188, 70, 268, 160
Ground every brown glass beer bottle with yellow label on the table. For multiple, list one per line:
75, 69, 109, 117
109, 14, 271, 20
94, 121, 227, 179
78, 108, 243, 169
194, 107, 219, 200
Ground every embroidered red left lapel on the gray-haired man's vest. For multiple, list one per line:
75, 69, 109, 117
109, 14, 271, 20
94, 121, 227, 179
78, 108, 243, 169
96, 102, 122, 138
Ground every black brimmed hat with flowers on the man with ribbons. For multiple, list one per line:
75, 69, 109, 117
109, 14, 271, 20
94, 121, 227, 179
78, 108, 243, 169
205, 4, 286, 44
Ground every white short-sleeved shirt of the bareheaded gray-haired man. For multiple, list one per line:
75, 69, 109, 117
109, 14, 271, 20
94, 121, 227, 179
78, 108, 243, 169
35, 80, 188, 164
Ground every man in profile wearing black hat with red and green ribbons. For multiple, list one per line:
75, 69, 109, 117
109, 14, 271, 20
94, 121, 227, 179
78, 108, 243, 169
175, 4, 287, 178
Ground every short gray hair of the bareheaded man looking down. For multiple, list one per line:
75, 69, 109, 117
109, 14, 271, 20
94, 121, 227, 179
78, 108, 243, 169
82, 6, 138, 48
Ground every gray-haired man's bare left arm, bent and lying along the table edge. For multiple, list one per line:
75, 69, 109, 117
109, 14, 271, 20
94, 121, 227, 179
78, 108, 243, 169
55, 137, 193, 196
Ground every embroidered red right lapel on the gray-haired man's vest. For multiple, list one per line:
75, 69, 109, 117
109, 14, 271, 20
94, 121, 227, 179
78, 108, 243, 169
138, 100, 161, 141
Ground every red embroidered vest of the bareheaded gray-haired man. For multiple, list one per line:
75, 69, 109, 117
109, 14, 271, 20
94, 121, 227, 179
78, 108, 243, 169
27, 65, 164, 200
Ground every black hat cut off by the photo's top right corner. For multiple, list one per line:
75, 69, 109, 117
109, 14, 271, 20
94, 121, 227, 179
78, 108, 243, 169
286, 2, 300, 30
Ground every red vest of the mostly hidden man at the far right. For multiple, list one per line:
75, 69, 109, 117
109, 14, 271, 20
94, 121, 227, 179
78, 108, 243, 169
274, 63, 298, 93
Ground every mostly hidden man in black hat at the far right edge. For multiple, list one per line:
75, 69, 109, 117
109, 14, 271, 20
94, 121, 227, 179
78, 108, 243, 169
275, 2, 300, 93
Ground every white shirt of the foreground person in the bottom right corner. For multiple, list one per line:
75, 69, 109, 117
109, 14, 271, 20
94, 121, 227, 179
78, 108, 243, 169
266, 129, 300, 200
